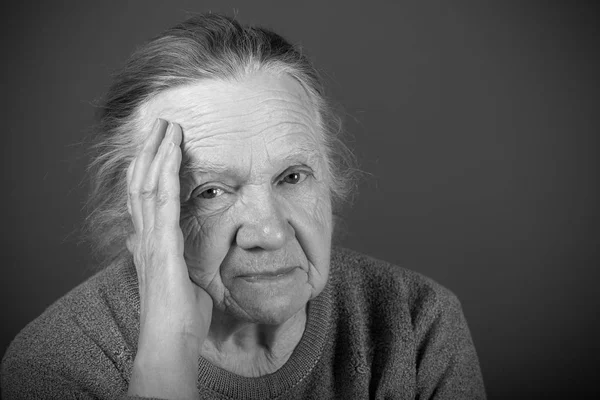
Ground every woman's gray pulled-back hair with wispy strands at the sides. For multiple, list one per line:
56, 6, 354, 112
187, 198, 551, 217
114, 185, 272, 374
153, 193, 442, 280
84, 14, 357, 264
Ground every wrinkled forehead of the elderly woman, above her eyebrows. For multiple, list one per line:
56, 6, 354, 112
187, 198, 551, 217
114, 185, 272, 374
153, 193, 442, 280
138, 73, 322, 153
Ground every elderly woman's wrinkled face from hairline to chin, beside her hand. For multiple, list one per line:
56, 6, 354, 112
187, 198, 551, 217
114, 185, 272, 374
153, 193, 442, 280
141, 72, 332, 324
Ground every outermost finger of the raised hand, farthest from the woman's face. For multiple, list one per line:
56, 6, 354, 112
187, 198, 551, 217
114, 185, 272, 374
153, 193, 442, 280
129, 118, 167, 232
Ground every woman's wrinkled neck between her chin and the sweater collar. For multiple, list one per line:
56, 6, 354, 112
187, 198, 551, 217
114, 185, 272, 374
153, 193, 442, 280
201, 307, 306, 377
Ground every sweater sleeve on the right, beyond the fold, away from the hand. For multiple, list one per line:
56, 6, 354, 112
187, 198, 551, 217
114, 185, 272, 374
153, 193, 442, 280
415, 288, 486, 400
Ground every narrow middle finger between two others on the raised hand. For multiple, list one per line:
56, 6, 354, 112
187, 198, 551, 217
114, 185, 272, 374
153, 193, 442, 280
142, 123, 173, 230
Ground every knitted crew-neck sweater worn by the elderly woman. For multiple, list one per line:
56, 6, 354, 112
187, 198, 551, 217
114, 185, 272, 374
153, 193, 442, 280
1, 248, 485, 400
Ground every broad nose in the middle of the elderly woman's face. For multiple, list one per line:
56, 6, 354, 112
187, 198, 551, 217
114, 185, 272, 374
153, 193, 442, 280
236, 188, 293, 250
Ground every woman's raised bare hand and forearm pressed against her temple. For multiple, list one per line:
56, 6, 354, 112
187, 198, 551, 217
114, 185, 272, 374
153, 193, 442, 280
127, 119, 212, 398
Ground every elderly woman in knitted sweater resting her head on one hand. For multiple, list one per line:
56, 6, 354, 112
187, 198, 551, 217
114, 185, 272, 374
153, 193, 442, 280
2, 14, 485, 399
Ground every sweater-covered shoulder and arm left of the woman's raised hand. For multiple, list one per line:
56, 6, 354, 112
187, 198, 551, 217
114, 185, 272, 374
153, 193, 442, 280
2, 258, 133, 396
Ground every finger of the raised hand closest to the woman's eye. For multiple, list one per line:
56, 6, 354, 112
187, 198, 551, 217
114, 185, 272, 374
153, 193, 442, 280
155, 123, 182, 229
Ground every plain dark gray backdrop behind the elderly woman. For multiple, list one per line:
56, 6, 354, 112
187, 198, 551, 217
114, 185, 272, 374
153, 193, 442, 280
0, 0, 600, 399
